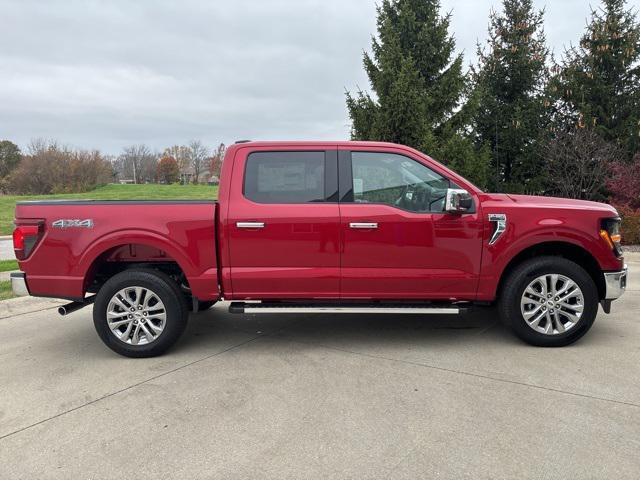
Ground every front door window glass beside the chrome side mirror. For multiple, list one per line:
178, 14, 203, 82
351, 152, 450, 212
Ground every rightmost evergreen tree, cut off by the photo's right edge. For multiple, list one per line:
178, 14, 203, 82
551, 0, 640, 158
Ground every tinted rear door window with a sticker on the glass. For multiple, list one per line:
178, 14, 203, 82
244, 152, 325, 203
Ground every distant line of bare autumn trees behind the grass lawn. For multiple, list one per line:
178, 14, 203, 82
0, 139, 226, 195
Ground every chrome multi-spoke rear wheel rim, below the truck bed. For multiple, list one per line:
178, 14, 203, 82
107, 286, 167, 345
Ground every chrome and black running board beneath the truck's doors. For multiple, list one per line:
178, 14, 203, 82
229, 302, 467, 315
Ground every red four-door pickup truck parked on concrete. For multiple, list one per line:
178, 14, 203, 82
12, 142, 627, 357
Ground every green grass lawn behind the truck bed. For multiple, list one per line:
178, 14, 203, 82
0, 184, 218, 235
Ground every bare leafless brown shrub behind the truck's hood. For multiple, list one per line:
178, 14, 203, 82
544, 128, 625, 200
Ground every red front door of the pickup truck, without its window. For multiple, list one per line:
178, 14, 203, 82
340, 147, 484, 299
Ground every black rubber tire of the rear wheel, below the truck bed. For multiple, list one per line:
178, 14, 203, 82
93, 268, 189, 358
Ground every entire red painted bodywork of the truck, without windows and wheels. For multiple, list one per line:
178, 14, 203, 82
16, 142, 623, 301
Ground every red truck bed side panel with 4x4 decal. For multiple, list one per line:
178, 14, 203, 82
16, 200, 218, 300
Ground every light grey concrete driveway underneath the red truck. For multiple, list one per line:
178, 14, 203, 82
0, 254, 640, 479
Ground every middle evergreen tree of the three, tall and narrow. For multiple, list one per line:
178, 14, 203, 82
473, 0, 550, 192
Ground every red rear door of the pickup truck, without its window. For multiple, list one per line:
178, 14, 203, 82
224, 146, 340, 299
